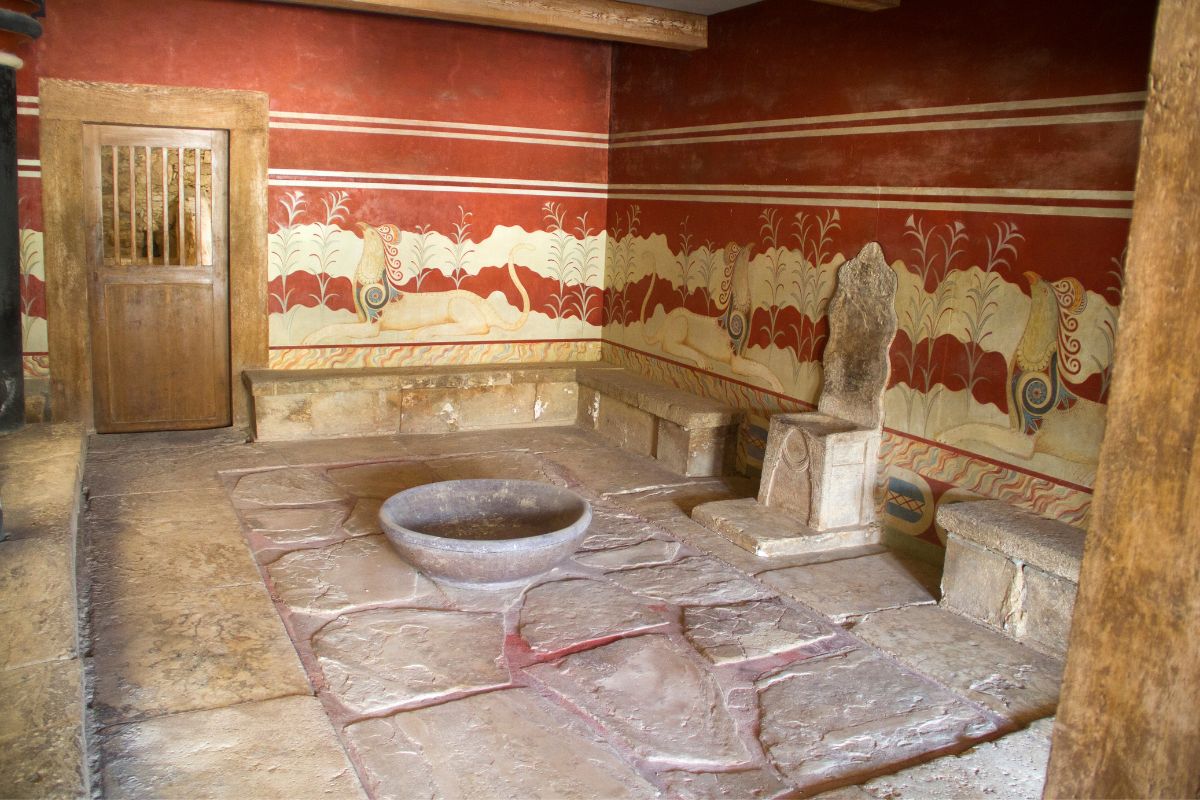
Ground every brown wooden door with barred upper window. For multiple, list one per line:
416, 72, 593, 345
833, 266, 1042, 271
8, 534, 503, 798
84, 125, 232, 433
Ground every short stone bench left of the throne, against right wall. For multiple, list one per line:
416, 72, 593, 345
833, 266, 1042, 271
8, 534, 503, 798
577, 366, 740, 477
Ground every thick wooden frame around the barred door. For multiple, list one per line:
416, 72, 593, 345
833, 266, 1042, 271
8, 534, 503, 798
38, 78, 269, 428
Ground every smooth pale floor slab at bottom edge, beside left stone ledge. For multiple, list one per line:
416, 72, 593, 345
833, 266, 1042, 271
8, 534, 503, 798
101, 697, 365, 800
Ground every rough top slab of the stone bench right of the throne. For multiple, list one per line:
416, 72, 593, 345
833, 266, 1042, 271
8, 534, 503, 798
937, 500, 1085, 583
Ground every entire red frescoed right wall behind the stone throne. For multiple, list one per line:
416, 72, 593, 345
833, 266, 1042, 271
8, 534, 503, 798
605, 0, 1154, 543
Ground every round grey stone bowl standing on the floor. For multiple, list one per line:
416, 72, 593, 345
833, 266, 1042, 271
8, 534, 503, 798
379, 480, 592, 587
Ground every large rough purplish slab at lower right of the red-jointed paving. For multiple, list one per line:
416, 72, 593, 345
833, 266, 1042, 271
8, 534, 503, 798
758, 649, 997, 789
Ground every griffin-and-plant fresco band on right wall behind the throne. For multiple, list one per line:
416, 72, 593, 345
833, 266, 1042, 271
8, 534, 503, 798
605, 204, 1127, 541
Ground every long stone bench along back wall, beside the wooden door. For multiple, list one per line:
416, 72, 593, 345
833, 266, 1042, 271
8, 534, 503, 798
242, 363, 578, 441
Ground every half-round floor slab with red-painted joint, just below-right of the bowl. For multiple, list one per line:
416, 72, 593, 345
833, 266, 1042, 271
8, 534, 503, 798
517, 579, 667, 652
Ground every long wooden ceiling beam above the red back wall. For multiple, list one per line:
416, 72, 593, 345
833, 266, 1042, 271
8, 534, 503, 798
265, 0, 708, 50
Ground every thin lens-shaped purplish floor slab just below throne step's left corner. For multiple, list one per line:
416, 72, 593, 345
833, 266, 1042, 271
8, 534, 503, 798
608, 555, 775, 606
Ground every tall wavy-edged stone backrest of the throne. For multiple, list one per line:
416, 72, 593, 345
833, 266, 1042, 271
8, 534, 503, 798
817, 242, 896, 428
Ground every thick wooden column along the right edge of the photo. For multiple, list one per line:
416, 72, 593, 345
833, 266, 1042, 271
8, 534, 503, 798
1045, 0, 1200, 798
